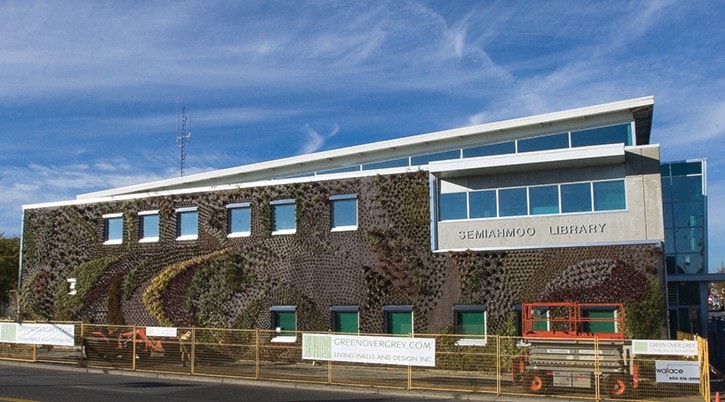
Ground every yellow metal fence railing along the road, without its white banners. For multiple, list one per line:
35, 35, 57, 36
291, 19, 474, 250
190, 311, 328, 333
0, 323, 710, 401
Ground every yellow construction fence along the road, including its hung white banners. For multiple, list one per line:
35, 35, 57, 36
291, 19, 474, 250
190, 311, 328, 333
0, 322, 710, 401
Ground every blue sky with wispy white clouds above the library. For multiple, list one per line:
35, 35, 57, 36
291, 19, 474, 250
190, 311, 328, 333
0, 0, 725, 271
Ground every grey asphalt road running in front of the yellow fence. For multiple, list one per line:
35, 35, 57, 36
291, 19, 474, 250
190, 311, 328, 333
0, 362, 548, 402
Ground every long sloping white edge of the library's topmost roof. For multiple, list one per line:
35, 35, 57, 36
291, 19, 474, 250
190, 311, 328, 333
76, 96, 654, 200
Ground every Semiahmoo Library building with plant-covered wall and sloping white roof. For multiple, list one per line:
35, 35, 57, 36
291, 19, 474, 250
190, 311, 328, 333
21, 97, 692, 342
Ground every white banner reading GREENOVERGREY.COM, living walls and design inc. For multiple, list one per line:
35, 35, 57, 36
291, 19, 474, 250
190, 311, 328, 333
302, 334, 435, 367
